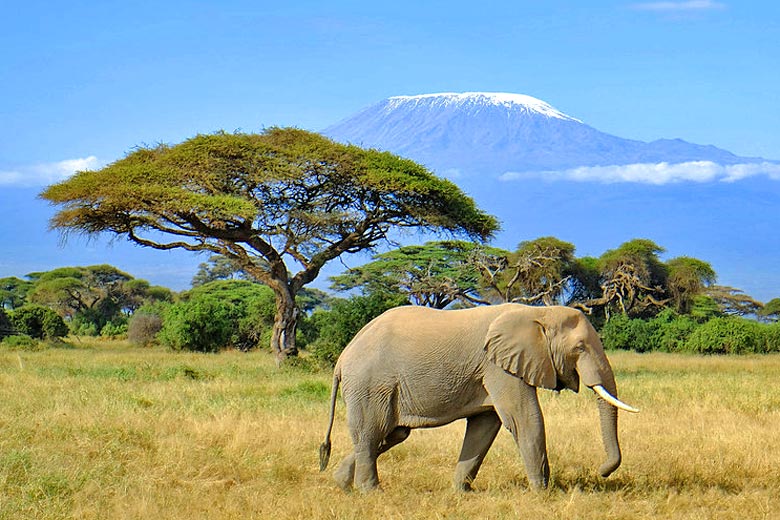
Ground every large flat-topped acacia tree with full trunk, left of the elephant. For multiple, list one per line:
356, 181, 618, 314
42, 128, 498, 361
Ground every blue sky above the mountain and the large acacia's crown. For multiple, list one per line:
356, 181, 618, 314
0, 0, 780, 292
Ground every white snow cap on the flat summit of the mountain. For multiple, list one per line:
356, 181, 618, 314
386, 92, 581, 123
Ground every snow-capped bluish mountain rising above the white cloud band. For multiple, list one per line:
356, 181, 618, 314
324, 92, 756, 176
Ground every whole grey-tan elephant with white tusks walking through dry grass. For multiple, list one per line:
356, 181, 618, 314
319, 303, 639, 491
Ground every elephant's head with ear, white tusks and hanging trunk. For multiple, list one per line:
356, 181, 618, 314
485, 305, 638, 477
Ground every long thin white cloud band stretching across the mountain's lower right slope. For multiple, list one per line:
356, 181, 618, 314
499, 161, 780, 186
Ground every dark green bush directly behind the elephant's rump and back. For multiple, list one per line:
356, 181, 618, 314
308, 293, 406, 363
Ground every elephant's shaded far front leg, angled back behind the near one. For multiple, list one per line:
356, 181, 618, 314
455, 411, 501, 491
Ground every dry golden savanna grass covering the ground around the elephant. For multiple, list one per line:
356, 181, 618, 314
0, 342, 780, 520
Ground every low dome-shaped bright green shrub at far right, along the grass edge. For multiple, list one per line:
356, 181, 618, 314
684, 317, 766, 354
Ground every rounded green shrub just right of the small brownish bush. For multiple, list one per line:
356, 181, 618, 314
157, 296, 235, 352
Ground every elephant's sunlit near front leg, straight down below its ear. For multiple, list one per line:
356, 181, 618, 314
485, 367, 550, 489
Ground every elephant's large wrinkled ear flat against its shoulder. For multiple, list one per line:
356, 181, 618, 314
485, 311, 558, 390
